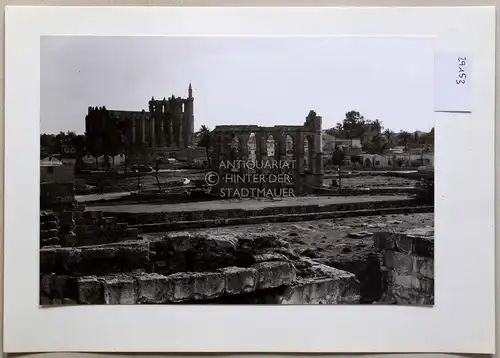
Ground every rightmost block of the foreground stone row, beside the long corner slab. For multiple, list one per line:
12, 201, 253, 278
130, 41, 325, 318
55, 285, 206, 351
252, 261, 296, 290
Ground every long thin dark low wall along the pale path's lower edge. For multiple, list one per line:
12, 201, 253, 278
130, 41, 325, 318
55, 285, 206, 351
104, 199, 419, 225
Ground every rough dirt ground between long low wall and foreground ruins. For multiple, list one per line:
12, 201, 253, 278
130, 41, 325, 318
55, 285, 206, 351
144, 213, 434, 260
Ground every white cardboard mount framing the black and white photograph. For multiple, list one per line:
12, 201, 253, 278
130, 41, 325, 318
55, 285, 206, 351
4, 7, 495, 353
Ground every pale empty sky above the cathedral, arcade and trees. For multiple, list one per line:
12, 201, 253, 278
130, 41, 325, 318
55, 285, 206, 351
40, 36, 434, 133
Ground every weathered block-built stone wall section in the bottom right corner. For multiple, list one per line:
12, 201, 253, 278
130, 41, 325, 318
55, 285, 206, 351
374, 228, 434, 305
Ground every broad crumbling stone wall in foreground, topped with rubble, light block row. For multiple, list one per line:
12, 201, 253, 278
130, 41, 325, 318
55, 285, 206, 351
40, 233, 360, 304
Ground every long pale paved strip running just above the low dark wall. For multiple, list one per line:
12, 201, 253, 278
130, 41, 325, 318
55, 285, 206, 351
86, 195, 410, 213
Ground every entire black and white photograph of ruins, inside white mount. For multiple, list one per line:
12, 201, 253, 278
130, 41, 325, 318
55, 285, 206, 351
39, 36, 435, 304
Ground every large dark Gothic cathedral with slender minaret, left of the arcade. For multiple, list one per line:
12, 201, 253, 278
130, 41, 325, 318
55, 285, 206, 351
85, 84, 194, 161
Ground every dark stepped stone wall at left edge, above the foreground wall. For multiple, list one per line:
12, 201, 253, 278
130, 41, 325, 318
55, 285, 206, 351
40, 210, 139, 247
